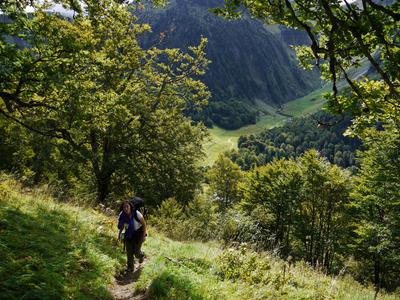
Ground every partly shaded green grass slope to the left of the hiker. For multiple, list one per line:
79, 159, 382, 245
0, 175, 124, 299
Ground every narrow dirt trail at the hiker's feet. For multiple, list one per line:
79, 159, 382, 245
108, 259, 148, 300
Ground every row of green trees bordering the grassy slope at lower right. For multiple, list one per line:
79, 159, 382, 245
200, 145, 400, 290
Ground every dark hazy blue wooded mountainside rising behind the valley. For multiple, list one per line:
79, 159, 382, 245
139, 0, 320, 129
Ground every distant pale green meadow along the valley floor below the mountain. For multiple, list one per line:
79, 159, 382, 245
204, 88, 328, 165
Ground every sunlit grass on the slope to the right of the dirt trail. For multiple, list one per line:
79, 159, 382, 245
135, 232, 396, 300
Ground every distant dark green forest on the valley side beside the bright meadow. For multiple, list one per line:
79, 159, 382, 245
230, 112, 361, 170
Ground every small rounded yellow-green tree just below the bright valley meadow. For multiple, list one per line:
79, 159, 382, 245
207, 154, 243, 210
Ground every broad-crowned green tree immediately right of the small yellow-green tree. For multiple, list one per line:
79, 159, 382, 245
242, 159, 302, 257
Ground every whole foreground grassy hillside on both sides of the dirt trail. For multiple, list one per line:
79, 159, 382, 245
0, 176, 395, 299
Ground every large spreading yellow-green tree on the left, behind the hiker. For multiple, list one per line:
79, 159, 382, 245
0, 0, 209, 202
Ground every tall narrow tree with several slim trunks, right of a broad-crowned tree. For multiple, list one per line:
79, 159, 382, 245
295, 150, 352, 271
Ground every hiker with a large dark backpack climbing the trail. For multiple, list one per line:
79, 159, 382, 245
118, 201, 147, 272
